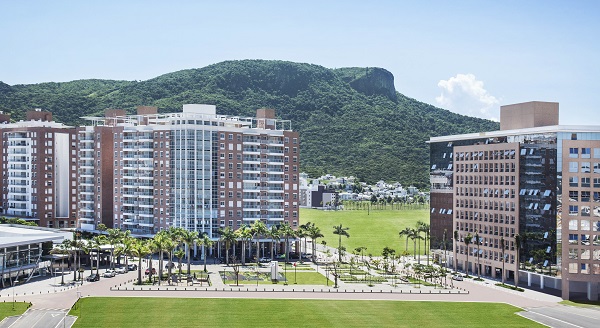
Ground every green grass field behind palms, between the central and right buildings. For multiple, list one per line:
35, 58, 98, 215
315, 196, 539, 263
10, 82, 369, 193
300, 208, 429, 255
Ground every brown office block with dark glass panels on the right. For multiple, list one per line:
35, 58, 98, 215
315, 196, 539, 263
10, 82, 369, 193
429, 102, 600, 300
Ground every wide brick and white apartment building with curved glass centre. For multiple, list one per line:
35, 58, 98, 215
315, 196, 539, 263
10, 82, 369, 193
77, 104, 300, 238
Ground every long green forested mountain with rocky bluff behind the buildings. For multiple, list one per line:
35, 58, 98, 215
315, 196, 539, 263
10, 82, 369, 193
0, 60, 499, 187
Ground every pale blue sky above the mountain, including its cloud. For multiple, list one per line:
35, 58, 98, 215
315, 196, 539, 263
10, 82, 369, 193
0, 0, 600, 124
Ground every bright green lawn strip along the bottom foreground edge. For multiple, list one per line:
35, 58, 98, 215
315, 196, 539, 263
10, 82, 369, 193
69, 297, 542, 328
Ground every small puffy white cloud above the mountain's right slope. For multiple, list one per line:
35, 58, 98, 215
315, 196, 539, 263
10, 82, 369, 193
435, 74, 500, 121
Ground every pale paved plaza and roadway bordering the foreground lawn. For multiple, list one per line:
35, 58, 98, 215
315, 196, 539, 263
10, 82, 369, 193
0, 261, 600, 328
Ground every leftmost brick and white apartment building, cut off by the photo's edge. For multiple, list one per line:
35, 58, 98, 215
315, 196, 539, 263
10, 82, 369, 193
0, 109, 77, 228
